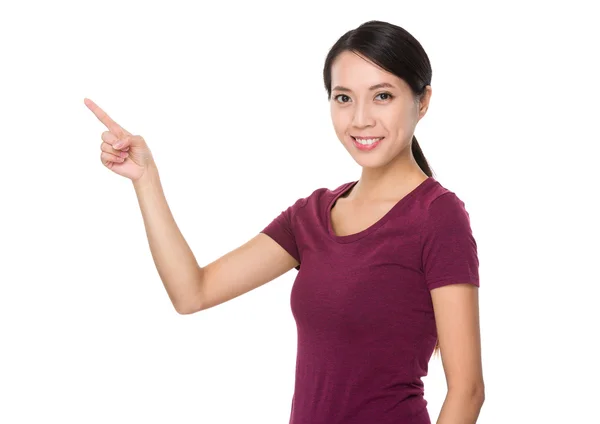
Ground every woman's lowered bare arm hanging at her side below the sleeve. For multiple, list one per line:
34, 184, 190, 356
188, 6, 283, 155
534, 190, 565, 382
431, 284, 485, 424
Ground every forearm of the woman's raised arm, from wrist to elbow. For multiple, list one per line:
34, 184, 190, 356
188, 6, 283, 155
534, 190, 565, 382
133, 162, 202, 313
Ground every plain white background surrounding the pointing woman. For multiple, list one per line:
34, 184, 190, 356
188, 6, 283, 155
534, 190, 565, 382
0, 1, 600, 424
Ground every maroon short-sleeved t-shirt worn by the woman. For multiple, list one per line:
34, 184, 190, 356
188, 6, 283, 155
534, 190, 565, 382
261, 177, 479, 424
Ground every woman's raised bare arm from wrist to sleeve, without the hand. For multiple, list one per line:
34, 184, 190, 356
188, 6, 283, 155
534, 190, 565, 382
133, 163, 298, 314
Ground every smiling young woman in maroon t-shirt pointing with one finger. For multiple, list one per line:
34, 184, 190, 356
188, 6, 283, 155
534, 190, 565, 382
85, 21, 484, 424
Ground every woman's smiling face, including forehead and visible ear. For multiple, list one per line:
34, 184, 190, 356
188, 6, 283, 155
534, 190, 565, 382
330, 51, 431, 168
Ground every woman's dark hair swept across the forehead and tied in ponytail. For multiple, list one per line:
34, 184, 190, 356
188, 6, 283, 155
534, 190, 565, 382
323, 21, 433, 177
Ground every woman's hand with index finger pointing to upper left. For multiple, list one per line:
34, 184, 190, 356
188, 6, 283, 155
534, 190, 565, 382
84, 98, 152, 181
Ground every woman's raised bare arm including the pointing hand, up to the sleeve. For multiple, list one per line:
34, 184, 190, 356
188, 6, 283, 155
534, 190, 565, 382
85, 99, 299, 314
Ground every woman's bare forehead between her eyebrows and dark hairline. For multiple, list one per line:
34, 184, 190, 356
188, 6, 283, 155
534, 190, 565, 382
331, 51, 406, 90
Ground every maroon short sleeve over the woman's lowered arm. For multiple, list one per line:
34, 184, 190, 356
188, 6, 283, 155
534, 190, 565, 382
421, 192, 479, 290
